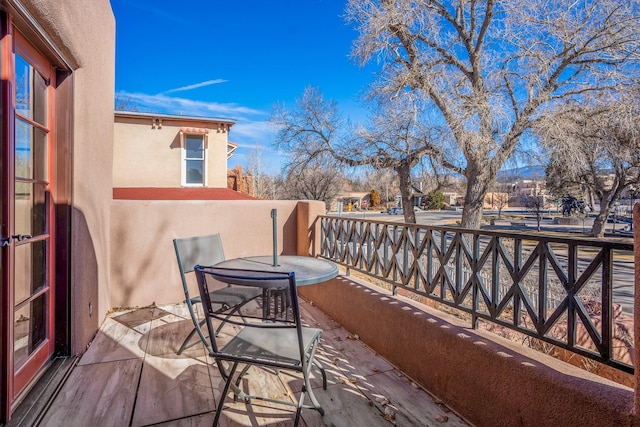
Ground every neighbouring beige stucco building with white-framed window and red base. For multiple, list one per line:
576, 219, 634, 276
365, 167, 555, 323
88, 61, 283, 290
113, 111, 251, 200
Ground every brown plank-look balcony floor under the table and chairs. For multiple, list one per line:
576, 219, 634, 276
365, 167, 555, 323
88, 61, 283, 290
42, 302, 468, 427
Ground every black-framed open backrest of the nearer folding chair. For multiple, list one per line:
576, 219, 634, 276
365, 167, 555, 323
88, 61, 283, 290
195, 266, 304, 366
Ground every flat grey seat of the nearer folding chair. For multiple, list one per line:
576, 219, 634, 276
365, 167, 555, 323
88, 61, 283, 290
220, 328, 322, 366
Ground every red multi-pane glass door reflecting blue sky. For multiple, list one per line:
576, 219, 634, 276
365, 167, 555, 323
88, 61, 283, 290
5, 36, 55, 399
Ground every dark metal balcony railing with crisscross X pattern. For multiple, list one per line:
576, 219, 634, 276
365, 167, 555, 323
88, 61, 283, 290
320, 216, 633, 373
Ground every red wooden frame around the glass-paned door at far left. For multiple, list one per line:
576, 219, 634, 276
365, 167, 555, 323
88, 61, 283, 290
0, 12, 57, 423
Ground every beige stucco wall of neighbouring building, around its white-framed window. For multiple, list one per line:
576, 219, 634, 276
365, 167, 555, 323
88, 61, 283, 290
113, 115, 229, 188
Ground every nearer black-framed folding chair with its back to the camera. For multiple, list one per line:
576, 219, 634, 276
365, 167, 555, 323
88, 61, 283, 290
195, 266, 327, 426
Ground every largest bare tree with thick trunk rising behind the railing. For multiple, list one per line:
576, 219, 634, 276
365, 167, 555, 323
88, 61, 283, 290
346, 0, 640, 228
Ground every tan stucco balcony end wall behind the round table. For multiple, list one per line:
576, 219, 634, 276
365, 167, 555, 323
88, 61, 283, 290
109, 200, 324, 308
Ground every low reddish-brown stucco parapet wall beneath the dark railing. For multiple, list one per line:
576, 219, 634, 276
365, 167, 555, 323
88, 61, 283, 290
300, 276, 637, 427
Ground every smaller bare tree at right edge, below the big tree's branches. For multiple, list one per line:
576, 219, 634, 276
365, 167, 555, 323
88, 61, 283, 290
537, 90, 640, 237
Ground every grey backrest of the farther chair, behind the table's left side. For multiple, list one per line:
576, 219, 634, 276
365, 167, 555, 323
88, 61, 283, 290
173, 233, 225, 300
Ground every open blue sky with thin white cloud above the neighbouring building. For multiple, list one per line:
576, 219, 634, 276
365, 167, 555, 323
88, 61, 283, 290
111, 0, 375, 172
